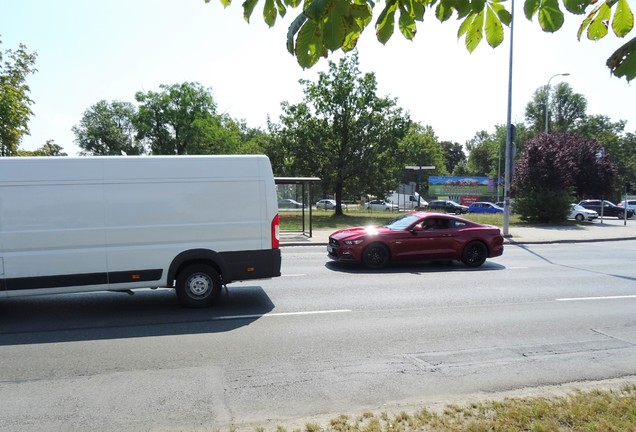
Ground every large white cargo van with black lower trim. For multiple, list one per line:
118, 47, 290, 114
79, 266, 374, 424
0, 156, 281, 307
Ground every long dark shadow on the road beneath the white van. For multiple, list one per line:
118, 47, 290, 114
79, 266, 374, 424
0, 286, 274, 346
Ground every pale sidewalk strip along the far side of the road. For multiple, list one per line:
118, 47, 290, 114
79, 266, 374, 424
280, 219, 636, 246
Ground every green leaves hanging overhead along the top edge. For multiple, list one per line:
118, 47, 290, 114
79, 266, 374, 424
205, 0, 636, 81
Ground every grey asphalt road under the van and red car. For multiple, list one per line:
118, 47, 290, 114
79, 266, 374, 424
0, 241, 636, 431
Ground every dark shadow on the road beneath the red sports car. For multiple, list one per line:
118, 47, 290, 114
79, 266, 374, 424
325, 260, 505, 274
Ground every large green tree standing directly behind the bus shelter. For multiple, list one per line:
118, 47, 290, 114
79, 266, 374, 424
276, 53, 410, 215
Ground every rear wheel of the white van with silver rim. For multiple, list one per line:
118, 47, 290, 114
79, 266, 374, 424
177, 264, 221, 308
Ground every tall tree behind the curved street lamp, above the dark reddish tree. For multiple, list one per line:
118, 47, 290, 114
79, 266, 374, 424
526, 83, 587, 135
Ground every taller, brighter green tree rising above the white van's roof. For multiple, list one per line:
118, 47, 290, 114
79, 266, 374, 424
135, 82, 219, 155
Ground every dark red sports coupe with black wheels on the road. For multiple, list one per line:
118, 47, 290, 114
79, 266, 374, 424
327, 212, 503, 269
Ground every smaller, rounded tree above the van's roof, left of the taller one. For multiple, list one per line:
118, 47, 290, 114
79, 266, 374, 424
72, 100, 144, 156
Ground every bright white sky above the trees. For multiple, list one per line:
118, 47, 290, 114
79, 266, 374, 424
0, 0, 636, 155
